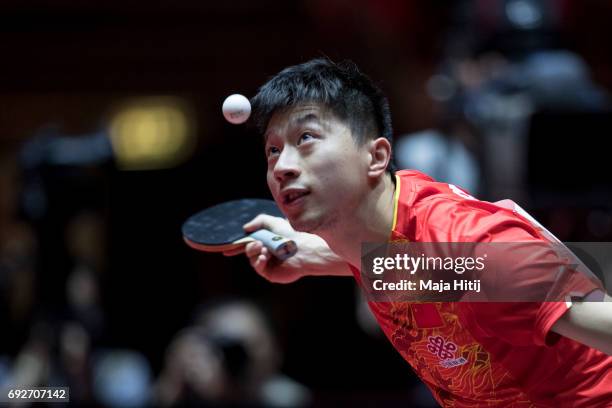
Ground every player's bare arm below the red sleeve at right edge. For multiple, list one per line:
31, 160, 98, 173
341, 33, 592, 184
551, 290, 612, 356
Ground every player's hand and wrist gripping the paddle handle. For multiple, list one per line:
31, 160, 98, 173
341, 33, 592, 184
223, 214, 351, 283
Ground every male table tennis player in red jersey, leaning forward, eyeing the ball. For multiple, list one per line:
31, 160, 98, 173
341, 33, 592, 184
226, 59, 612, 407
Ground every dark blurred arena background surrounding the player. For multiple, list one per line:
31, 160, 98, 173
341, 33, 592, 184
0, 0, 612, 407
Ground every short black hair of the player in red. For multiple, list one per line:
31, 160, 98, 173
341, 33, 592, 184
251, 58, 395, 174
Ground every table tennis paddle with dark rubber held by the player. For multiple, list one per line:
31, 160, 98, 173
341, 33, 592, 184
182, 198, 297, 260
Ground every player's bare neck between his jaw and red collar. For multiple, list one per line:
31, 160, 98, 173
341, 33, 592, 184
320, 175, 395, 267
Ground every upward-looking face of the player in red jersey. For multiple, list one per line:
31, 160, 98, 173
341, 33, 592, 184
265, 104, 369, 232
